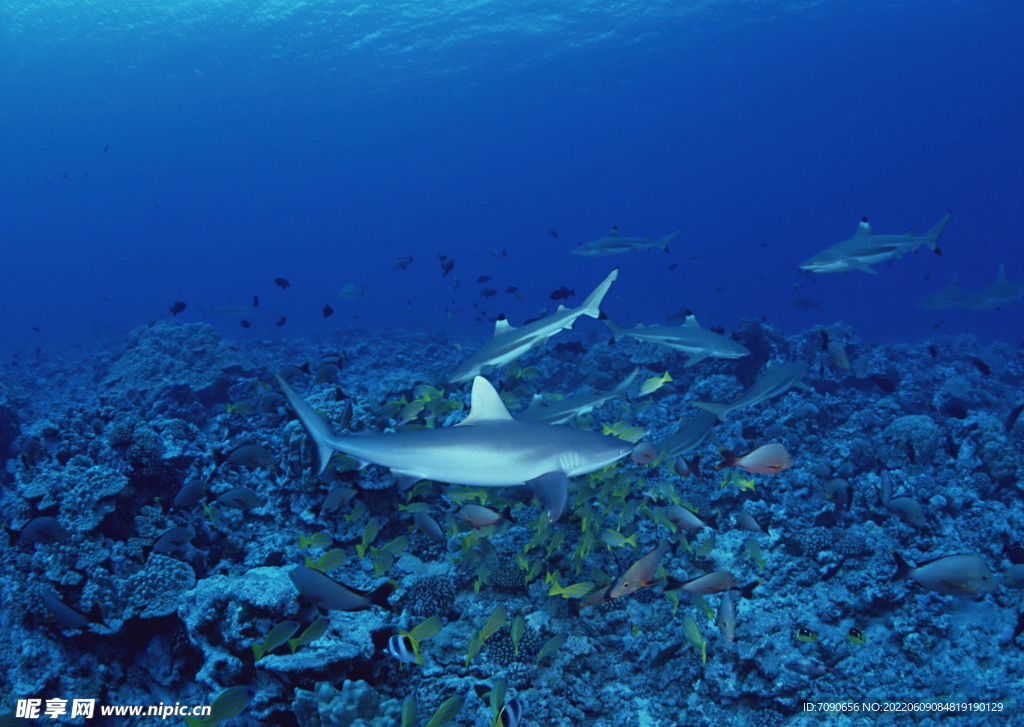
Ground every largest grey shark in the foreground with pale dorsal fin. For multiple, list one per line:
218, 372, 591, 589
275, 375, 654, 522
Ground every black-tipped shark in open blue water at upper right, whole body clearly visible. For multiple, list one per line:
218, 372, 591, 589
800, 212, 952, 274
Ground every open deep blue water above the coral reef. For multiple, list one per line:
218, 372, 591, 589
0, 2, 1024, 346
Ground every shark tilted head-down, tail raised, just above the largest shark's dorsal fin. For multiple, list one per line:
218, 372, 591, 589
450, 268, 618, 384
